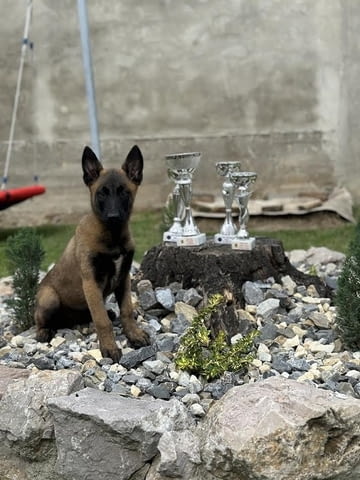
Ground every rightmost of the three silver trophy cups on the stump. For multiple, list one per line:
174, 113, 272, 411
230, 172, 257, 250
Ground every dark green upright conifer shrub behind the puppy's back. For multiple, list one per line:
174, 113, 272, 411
5, 228, 44, 332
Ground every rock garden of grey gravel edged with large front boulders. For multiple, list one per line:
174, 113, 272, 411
0, 240, 360, 480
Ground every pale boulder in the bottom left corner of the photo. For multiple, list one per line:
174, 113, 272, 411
0, 369, 84, 480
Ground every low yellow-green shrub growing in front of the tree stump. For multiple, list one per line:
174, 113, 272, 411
175, 295, 259, 380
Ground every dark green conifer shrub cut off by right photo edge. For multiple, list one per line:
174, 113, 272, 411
335, 222, 360, 350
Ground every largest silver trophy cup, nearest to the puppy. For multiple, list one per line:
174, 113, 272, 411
163, 152, 206, 246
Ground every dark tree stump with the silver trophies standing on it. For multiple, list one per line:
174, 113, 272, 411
140, 238, 331, 335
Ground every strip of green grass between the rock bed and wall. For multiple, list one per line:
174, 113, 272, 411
0, 208, 360, 277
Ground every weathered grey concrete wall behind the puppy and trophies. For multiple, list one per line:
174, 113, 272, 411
0, 0, 360, 220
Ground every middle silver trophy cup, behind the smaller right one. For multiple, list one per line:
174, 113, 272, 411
214, 162, 241, 244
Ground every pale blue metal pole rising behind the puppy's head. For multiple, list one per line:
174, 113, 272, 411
78, 0, 101, 157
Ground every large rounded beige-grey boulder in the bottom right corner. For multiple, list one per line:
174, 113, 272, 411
198, 377, 360, 480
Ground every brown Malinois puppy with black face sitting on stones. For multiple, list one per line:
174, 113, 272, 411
35, 146, 149, 362
